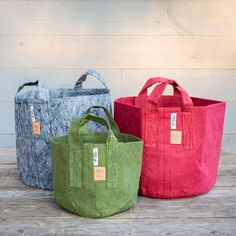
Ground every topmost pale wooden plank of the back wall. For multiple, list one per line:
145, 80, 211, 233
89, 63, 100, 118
0, 1, 236, 35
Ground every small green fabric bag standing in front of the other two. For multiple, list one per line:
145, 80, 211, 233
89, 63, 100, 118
51, 106, 143, 218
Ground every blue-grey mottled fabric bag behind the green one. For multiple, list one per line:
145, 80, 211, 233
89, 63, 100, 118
15, 70, 111, 190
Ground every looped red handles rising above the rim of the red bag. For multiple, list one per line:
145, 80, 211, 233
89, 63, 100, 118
138, 77, 193, 111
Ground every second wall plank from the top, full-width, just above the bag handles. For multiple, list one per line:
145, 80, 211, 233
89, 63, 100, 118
0, 36, 236, 69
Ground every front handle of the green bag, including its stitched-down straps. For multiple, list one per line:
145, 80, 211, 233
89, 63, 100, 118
68, 113, 118, 188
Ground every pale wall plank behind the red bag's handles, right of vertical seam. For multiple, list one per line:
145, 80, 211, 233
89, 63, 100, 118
120, 68, 236, 102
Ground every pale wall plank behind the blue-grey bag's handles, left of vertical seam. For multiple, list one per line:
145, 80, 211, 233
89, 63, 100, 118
0, 68, 121, 102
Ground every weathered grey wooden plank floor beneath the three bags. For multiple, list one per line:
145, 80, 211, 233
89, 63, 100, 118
0, 148, 236, 236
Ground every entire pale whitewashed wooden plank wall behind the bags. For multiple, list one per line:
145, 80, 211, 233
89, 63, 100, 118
0, 0, 236, 152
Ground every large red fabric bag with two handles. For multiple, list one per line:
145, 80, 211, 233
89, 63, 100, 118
114, 78, 225, 198
